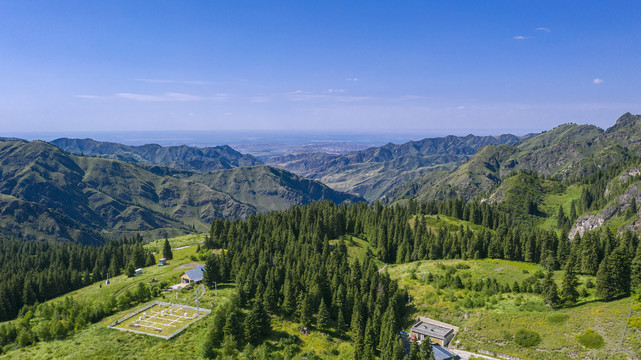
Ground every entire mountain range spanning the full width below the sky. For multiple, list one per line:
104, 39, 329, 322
0, 113, 641, 243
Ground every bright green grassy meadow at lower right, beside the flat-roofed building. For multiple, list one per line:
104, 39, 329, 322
386, 259, 631, 359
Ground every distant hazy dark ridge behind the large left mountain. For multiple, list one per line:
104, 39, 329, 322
51, 138, 262, 172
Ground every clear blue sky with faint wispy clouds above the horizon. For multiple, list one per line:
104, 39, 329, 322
0, 0, 641, 137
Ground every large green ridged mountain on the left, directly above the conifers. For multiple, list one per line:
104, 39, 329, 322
0, 141, 359, 243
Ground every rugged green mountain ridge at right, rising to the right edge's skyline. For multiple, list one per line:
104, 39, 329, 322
389, 113, 641, 205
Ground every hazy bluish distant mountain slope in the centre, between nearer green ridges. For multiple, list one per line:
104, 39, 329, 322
268, 134, 529, 201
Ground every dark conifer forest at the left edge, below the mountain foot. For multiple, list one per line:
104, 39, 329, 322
0, 235, 155, 321
